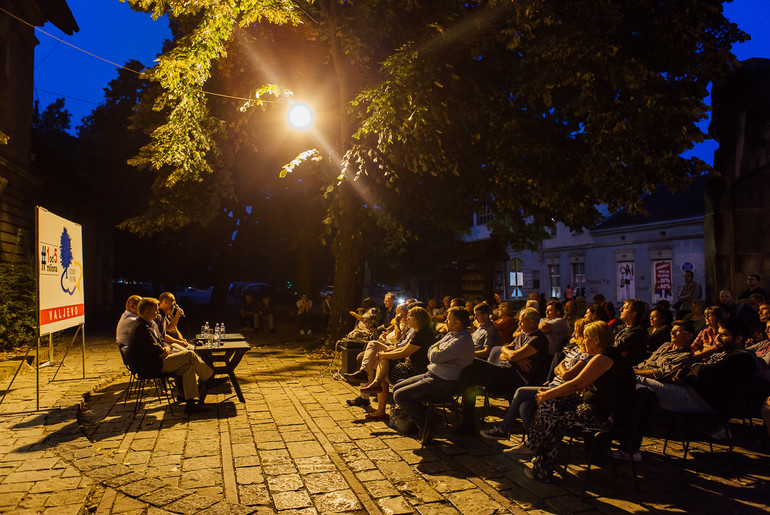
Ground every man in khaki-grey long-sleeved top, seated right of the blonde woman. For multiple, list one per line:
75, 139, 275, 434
634, 320, 695, 383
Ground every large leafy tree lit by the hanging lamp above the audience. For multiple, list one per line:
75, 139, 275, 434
121, 0, 745, 342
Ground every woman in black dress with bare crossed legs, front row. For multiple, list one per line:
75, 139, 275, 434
361, 307, 436, 420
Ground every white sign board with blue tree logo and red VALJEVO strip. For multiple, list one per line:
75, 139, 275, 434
36, 206, 85, 336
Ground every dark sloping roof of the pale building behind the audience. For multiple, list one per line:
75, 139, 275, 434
594, 175, 706, 230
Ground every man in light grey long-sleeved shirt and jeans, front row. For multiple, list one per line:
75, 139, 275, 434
393, 307, 473, 443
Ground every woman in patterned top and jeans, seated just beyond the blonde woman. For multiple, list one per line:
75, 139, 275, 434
481, 318, 591, 440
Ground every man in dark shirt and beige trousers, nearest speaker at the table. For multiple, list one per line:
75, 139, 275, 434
128, 298, 225, 413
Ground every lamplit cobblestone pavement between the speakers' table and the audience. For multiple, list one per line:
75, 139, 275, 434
0, 335, 770, 514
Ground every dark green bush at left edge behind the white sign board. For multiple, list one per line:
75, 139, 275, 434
0, 234, 38, 351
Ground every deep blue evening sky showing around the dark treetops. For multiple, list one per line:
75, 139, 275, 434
34, 0, 770, 163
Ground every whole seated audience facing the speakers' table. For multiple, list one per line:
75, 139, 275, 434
344, 294, 770, 481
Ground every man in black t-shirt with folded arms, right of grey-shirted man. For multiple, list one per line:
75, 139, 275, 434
462, 308, 551, 434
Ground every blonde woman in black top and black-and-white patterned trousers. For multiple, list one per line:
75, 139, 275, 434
511, 322, 636, 482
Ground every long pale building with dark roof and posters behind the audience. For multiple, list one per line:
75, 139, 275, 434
461, 178, 704, 304
